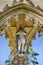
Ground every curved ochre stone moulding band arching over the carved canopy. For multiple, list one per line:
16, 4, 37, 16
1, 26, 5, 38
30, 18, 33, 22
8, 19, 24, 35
0, 3, 43, 21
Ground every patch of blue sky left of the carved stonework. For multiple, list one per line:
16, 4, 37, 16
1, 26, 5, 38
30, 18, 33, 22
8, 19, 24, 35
0, 35, 10, 65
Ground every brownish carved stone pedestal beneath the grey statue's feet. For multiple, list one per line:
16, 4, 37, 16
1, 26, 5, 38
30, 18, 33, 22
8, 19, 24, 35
13, 55, 29, 65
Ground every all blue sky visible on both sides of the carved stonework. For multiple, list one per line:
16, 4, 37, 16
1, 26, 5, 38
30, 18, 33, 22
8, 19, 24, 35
0, 33, 43, 65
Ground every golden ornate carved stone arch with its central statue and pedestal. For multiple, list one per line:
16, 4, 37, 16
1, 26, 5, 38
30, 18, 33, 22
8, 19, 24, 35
0, 4, 43, 65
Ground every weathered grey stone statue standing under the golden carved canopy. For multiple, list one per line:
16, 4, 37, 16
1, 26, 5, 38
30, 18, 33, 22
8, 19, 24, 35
16, 30, 27, 55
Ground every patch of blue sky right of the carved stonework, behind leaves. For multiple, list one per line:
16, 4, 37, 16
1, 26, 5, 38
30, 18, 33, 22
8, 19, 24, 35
32, 33, 43, 65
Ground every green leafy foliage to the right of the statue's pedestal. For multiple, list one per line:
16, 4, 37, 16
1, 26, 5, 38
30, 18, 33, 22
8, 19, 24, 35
28, 47, 39, 65
